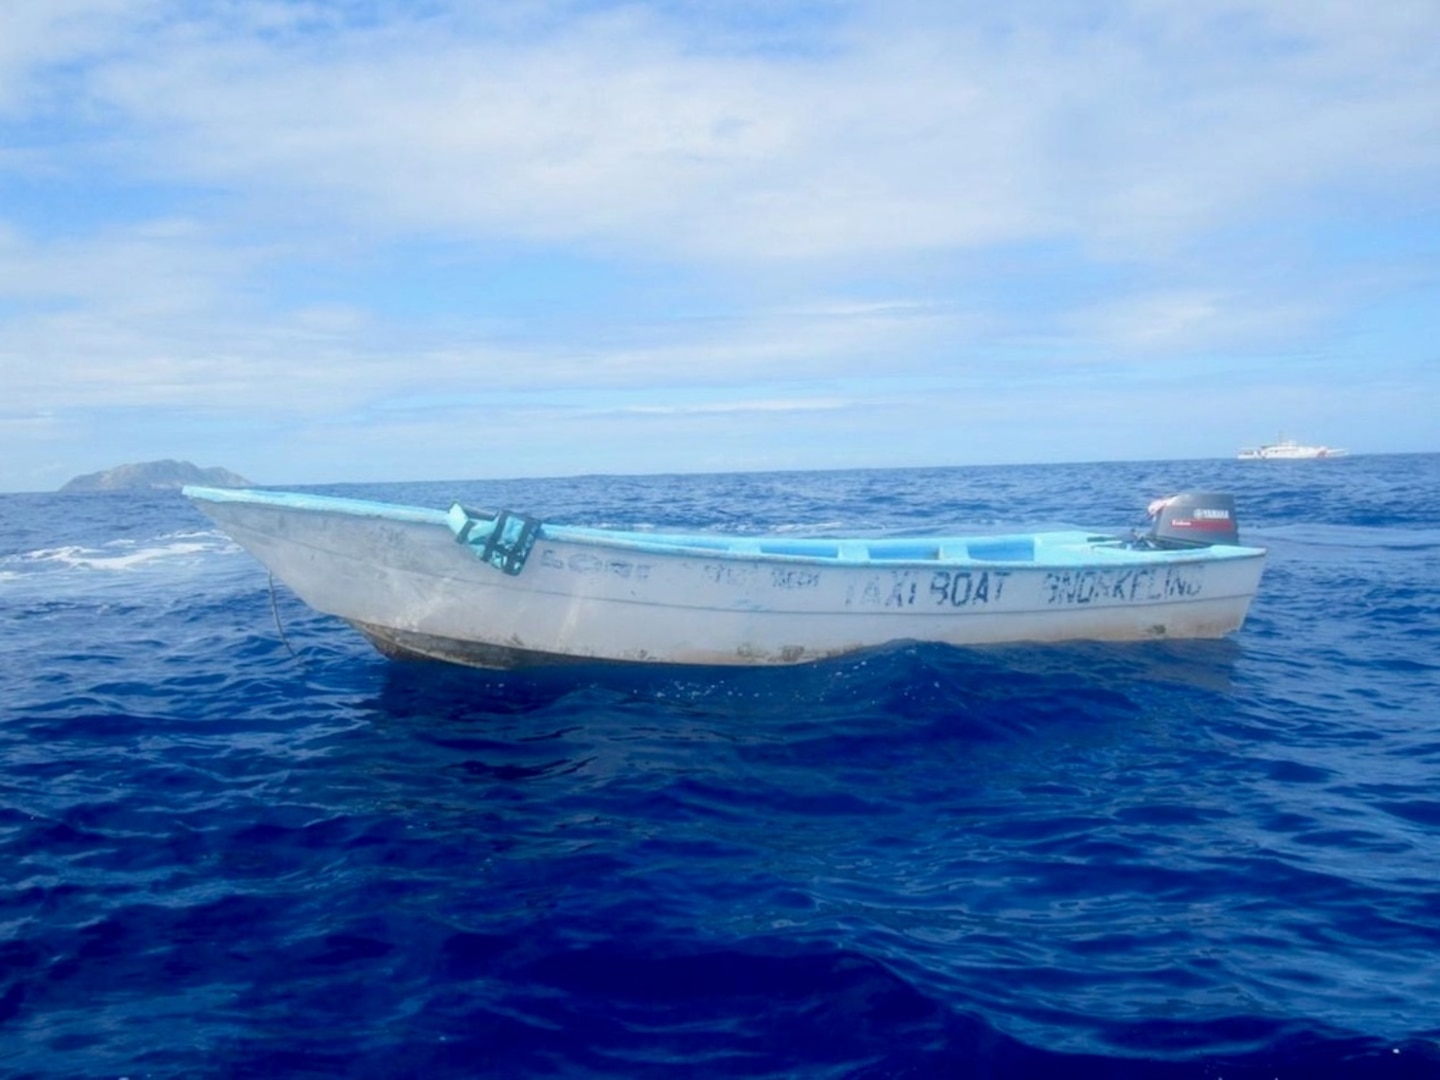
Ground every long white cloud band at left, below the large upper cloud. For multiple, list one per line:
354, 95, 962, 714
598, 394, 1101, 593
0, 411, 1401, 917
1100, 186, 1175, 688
0, 246, 963, 415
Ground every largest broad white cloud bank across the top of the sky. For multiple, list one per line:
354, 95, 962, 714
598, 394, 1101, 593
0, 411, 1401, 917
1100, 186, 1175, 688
36, 0, 1440, 261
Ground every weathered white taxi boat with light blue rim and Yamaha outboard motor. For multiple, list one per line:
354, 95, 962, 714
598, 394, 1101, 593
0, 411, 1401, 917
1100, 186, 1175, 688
184, 487, 1266, 668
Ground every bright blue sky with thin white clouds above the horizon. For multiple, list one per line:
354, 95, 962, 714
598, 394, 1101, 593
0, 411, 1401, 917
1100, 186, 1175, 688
0, 0, 1440, 491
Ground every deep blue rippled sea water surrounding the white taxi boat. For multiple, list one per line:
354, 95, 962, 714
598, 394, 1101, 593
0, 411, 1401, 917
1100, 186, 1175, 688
0, 455, 1440, 1079
